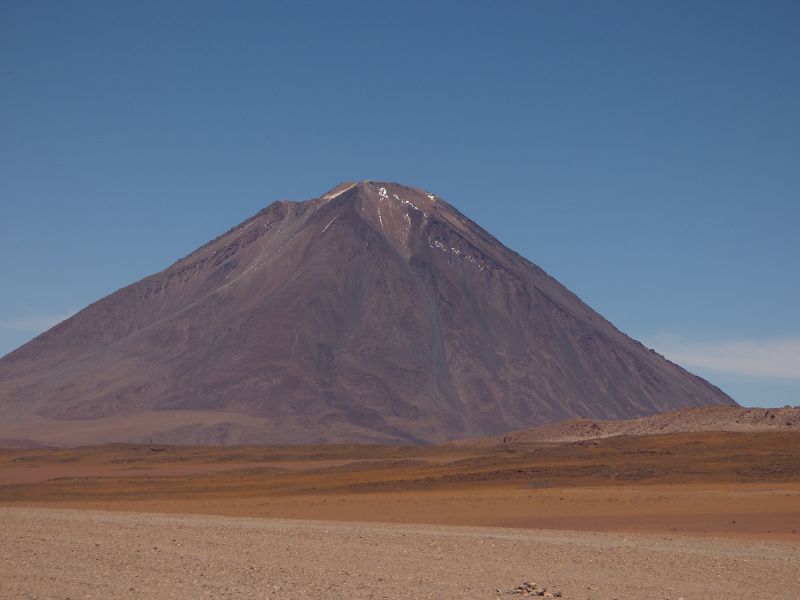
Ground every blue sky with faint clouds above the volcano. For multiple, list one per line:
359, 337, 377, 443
0, 0, 800, 406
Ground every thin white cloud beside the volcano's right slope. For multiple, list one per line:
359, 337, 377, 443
648, 335, 800, 381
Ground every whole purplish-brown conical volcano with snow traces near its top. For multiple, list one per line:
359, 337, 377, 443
0, 181, 735, 443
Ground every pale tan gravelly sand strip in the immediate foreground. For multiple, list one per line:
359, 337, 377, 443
0, 507, 800, 600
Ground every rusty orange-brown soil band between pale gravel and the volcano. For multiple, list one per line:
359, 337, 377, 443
0, 432, 800, 541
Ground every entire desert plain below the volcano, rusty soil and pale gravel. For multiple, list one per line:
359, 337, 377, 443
0, 431, 800, 600
